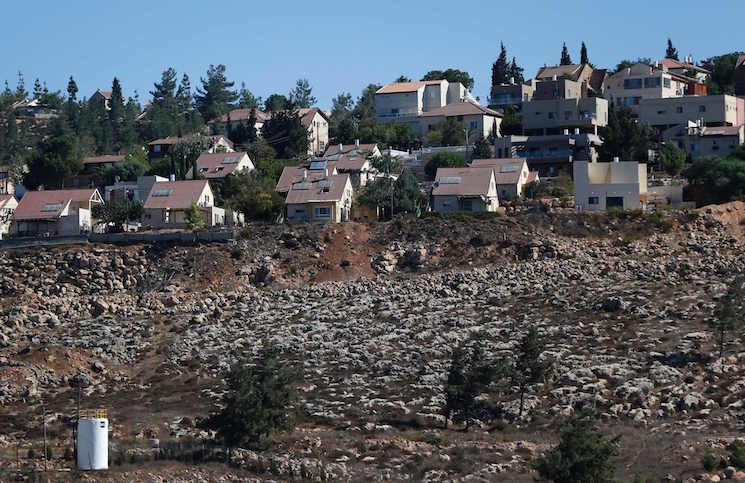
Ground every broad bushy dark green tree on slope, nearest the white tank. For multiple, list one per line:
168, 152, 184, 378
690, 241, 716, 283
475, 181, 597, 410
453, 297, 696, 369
204, 343, 302, 450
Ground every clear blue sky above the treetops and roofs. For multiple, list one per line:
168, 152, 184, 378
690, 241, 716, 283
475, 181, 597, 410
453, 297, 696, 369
0, 0, 745, 108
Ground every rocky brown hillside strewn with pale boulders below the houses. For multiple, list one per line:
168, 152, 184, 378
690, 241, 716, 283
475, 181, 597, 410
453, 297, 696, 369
0, 204, 745, 481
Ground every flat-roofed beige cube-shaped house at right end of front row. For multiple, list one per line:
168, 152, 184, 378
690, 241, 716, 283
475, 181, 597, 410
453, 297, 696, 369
573, 160, 647, 211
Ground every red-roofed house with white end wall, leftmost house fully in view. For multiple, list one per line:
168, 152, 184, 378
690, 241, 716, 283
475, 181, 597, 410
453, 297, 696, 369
11, 188, 103, 236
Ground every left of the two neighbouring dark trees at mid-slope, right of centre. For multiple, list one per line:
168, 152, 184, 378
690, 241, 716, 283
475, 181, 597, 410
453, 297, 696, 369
443, 337, 496, 431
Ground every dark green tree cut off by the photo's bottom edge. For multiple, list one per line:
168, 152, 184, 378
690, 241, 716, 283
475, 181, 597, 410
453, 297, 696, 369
535, 413, 620, 483
